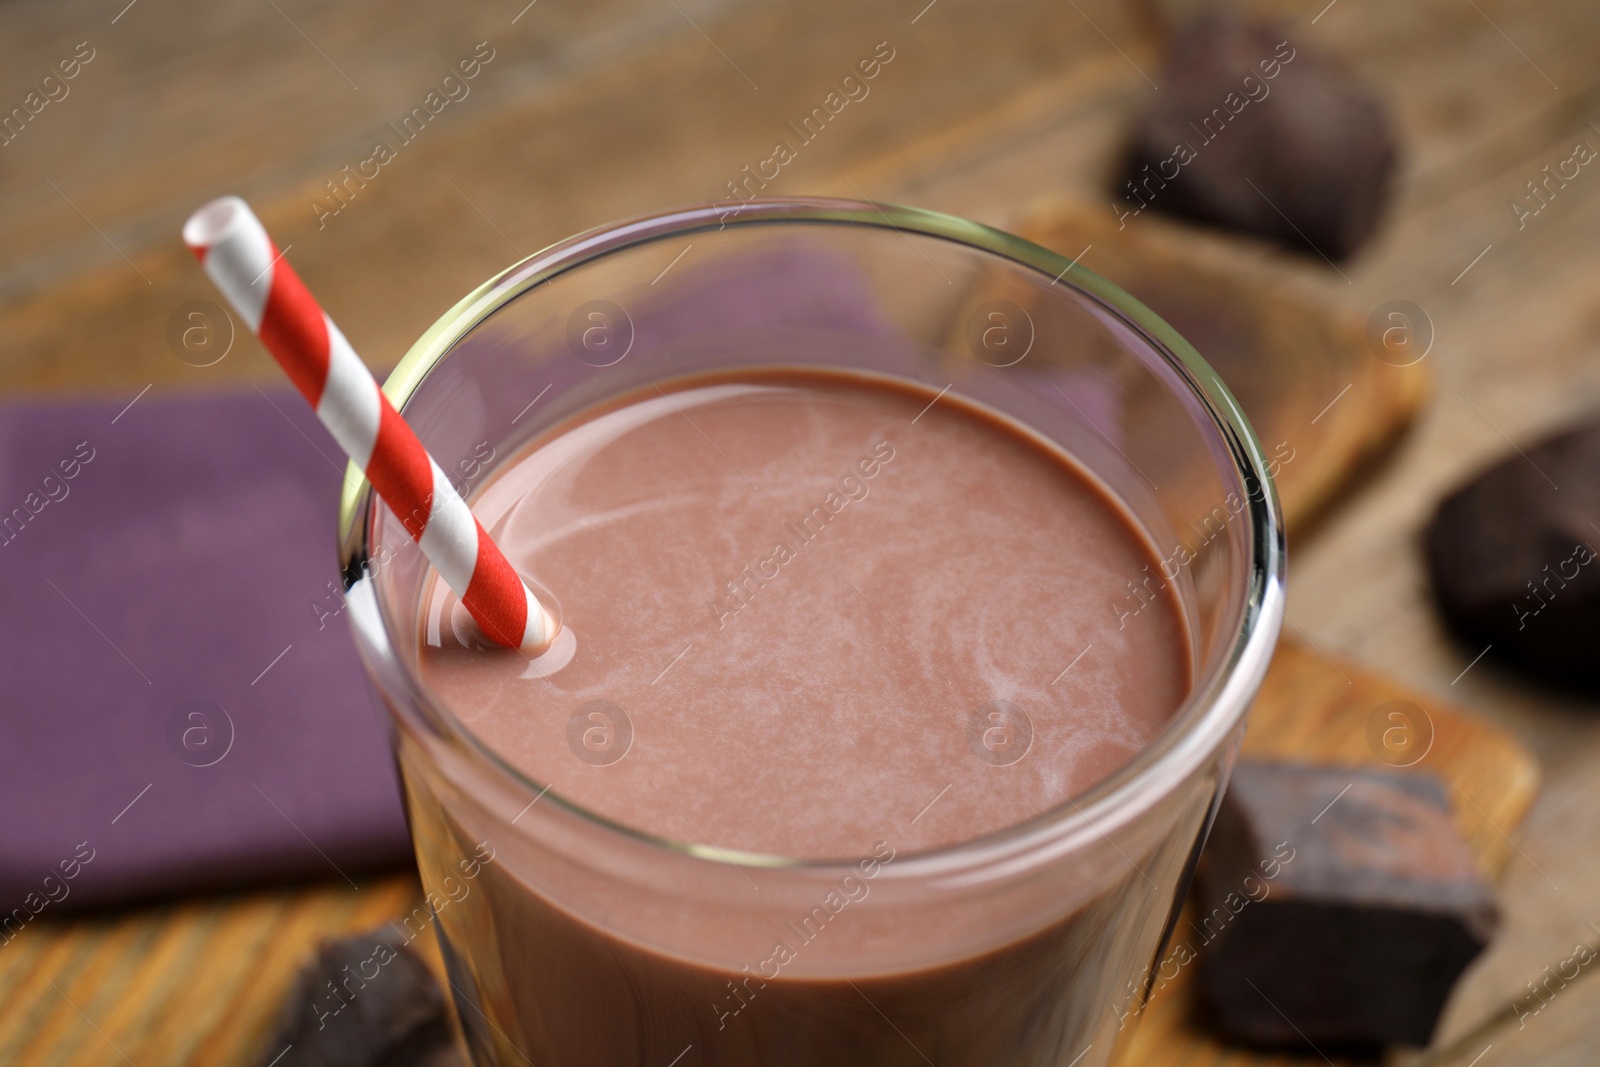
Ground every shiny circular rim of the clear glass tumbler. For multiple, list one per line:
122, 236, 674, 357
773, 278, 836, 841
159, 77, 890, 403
339, 197, 1286, 877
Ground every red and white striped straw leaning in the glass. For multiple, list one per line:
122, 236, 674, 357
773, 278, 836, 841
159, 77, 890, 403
184, 197, 557, 654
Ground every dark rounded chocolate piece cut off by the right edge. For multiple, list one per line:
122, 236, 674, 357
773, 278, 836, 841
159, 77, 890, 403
1426, 422, 1600, 689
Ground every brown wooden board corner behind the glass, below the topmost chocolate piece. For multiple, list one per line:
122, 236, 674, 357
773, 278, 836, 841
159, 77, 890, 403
1014, 195, 1432, 531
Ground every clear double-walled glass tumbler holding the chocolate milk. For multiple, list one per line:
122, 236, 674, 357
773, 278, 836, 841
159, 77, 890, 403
341, 200, 1285, 1067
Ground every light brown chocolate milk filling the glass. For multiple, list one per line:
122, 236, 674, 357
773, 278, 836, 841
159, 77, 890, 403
402, 371, 1200, 1067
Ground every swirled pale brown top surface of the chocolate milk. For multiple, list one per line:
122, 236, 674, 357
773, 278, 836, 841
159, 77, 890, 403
422, 373, 1190, 859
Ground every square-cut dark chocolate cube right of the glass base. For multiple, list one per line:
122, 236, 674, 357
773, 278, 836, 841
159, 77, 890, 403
1203, 761, 1499, 1046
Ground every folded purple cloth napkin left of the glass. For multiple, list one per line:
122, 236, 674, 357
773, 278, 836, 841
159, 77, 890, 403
0, 390, 410, 921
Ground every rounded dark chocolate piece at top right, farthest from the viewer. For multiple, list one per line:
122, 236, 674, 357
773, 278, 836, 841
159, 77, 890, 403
1114, 14, 1395, 259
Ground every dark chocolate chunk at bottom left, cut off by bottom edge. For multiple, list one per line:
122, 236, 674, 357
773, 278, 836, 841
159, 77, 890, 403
258, 926, 466, 1067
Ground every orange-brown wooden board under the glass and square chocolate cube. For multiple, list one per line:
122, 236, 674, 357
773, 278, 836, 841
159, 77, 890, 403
0, 643, 1539, 1067
